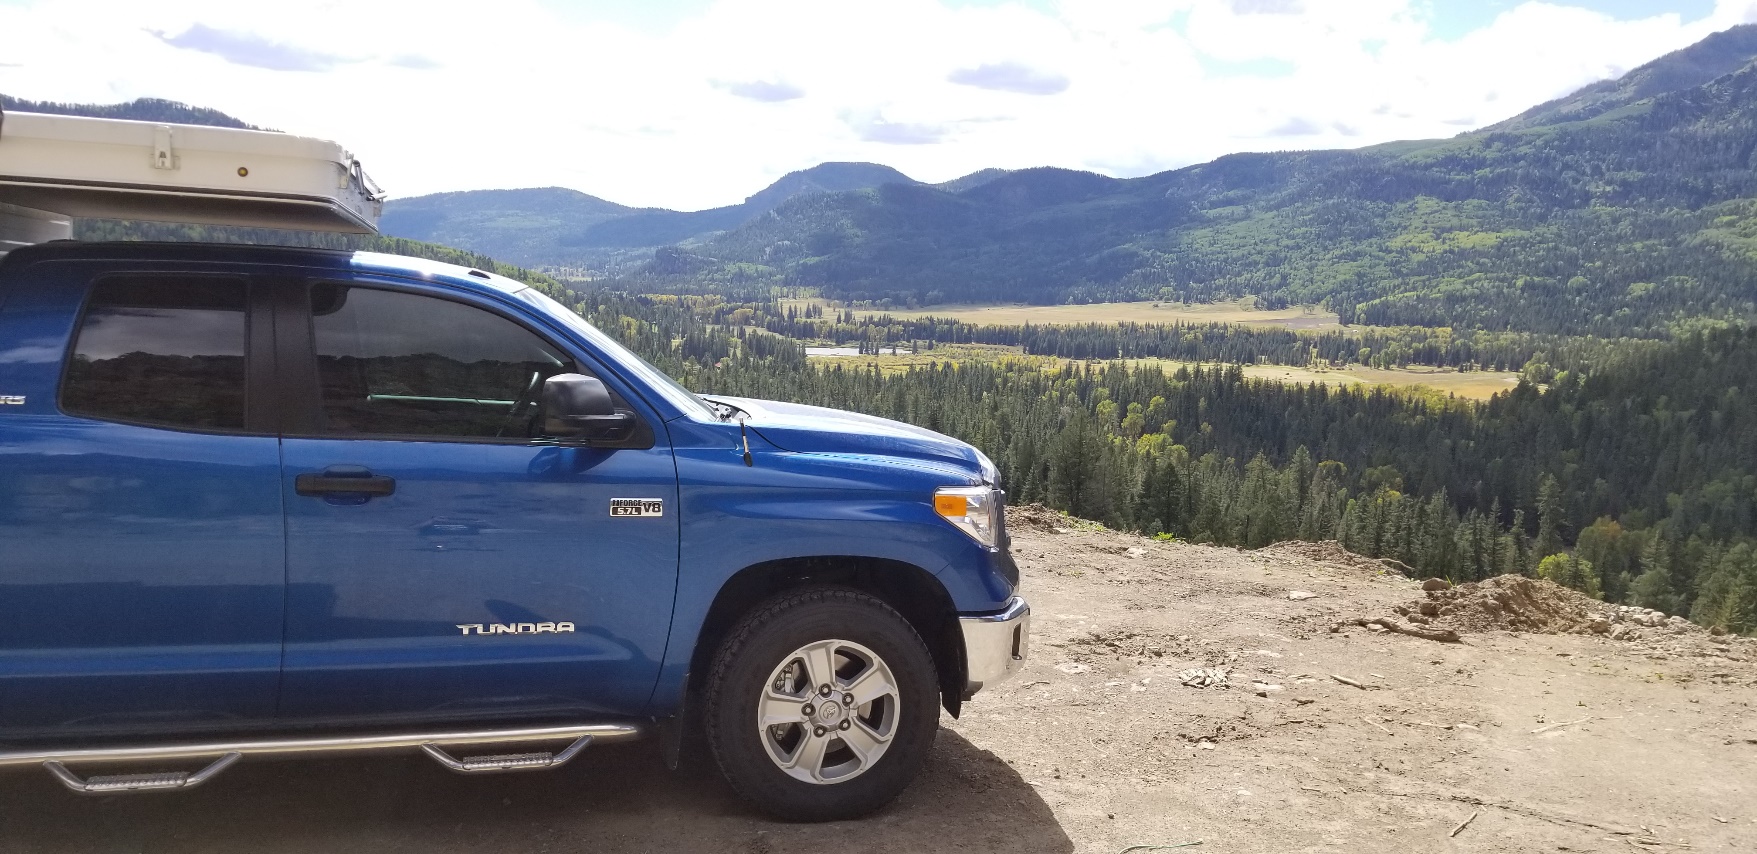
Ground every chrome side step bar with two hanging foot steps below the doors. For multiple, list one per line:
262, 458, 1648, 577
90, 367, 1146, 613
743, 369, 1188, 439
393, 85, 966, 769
0, 722, 648, 794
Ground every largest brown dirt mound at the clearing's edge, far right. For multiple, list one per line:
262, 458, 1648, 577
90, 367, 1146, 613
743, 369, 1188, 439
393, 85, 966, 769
1395, 575, 1611, 634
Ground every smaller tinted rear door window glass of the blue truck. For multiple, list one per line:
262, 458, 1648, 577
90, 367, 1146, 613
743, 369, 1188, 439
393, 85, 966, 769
61, 276, 248, 431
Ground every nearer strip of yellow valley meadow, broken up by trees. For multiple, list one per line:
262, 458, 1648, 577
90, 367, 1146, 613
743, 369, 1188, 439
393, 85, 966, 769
812, 344, 1520, 401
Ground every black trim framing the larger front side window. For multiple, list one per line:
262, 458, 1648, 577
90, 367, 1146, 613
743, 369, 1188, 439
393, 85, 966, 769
274, 276, 657, 450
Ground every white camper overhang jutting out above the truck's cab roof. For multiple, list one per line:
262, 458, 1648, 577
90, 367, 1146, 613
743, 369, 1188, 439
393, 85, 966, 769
0, 103, 385, 253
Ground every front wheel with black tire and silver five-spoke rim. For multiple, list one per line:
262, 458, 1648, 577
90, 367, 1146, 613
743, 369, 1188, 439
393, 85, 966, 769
706, 587, 940, 821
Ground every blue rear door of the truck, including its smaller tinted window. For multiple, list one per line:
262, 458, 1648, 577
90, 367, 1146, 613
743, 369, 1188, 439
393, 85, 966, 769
0, 272, 285, 736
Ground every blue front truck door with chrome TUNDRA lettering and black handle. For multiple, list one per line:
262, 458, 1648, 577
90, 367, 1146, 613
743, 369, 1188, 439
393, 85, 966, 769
281, 279, 678, 719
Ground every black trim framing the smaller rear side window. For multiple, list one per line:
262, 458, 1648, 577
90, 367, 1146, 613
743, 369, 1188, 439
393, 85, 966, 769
54, 271, 279, 438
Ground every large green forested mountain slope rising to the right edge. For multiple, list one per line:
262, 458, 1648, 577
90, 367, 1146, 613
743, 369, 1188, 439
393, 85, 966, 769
639, 25, 1757, 336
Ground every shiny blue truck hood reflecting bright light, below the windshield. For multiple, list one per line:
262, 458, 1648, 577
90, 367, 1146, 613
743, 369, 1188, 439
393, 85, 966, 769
706, 395, 994, 483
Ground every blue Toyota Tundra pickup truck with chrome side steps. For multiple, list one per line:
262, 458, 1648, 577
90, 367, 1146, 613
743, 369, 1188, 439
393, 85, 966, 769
0, 241, 1030, 821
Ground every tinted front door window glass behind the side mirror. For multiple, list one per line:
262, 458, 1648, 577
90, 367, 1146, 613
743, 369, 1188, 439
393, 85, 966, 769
311, 283, 578, 438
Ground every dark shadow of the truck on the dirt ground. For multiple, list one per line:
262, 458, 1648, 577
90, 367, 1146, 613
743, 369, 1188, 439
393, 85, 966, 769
0, 727, 1074, 854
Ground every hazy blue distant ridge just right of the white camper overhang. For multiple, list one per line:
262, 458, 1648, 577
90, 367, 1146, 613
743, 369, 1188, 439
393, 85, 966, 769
381, 163, 915, 265
